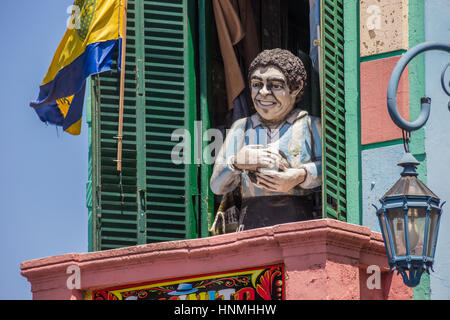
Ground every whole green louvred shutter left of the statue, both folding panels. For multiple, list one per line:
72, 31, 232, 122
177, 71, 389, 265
91, 0, 198, 250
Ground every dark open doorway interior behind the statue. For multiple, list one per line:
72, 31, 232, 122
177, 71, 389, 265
206, 0, 322, 222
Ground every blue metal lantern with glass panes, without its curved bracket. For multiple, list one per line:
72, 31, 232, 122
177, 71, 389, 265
377, 153, 445, 287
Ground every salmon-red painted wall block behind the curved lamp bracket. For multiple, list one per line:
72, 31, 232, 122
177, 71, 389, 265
361, 56, 409, 145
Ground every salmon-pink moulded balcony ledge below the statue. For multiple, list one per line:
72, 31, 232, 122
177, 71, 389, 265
21, 219, 413, 300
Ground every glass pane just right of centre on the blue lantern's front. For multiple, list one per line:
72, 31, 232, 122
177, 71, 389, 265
408, 207, 426, 256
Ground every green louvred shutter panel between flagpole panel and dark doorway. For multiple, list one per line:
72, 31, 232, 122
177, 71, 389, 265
142, 0, 198, 242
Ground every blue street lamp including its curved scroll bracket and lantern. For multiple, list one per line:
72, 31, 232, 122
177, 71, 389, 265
374, 42, 450, 287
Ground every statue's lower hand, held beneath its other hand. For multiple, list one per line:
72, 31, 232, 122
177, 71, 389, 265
256, 168, 306, 193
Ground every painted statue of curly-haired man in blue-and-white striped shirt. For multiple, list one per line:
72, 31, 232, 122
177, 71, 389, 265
211, 49, 322, 230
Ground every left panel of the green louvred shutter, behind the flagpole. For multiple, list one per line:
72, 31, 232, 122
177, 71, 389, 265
91, 1, 138, 251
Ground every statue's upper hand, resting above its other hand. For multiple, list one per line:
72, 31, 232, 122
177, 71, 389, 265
233, 145, 282, 171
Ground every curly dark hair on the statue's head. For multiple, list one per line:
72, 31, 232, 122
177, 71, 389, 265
248, 48, 307, 101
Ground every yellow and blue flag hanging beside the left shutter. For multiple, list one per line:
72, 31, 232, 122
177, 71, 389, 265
30, 0, 123, 135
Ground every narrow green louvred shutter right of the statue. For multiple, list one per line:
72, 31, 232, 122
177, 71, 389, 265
321, 0, 347, 221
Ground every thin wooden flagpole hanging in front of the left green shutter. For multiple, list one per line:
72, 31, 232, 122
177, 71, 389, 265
117, 0, 128, 171
